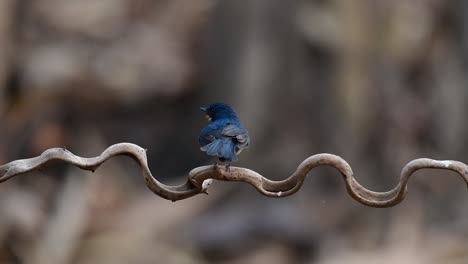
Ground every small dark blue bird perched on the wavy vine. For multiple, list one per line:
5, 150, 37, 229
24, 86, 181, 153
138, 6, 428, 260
198, 103, 250, 164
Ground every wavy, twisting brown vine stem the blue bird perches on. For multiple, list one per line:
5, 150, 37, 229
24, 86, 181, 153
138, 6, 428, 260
0, 143, 468, 207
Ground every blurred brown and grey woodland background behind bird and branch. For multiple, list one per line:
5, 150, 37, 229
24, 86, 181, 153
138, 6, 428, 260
0, 0, 468, 264
